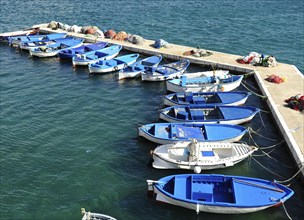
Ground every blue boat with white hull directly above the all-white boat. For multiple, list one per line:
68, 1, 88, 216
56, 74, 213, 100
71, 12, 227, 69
138, 123, 247, 144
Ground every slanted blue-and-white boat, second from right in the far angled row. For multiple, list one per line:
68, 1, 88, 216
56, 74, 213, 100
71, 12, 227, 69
117, 55, 162, 80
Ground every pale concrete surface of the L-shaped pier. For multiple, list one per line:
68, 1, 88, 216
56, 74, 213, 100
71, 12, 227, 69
1, 24, 304, 177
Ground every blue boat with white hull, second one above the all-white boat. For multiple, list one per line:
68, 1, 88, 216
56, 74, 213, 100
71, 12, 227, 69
159, 105, 260, 124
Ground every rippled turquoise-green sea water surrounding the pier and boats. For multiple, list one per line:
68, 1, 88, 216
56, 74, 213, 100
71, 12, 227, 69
0, 0, 304, 220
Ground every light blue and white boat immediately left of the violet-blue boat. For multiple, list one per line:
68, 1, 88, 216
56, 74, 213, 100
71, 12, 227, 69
30, 38, 83, 57
